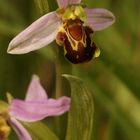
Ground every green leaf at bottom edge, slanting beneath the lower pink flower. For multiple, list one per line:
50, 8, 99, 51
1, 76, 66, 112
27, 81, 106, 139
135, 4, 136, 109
23, 122, 59, 140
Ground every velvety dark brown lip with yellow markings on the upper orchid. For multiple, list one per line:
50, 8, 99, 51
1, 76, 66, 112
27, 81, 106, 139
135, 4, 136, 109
56, 19, 97, 64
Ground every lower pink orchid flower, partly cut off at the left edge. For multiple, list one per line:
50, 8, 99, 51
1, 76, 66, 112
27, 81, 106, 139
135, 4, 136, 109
0, 75, 70, 140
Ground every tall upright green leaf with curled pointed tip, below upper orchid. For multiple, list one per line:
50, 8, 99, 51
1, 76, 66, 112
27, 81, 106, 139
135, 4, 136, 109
63, 75, 94, 140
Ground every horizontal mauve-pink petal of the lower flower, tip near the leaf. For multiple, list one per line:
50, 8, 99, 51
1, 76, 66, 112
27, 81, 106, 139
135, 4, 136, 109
9, 97, 70, 122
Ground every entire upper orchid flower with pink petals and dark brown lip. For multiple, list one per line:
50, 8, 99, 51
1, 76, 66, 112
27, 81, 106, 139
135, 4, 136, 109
7, 0, 115, 63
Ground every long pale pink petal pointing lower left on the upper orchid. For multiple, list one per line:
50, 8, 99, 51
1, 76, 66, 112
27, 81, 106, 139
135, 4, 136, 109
7, 12, 61, 54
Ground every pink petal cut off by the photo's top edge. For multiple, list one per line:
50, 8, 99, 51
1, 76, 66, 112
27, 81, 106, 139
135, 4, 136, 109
57, 0, 81, 8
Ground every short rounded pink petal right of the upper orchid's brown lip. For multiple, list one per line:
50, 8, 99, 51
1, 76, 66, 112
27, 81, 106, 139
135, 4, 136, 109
85, 8, 115, 31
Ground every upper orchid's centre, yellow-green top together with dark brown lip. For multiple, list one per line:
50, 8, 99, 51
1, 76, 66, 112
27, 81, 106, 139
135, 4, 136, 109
56, 5, 100, 64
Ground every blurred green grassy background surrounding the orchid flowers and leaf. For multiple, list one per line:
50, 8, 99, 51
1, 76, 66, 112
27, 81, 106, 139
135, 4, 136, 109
0, 0, 140, 140
